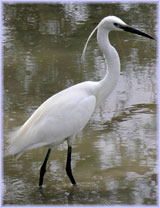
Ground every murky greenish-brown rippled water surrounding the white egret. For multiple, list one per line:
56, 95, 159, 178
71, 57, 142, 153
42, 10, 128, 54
3, 3, 157, 205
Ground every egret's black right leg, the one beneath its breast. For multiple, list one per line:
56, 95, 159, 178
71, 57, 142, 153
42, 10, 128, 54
66, 146, 77, 186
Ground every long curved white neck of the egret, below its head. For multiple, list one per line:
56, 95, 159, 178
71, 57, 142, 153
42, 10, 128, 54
96, 27, 120, 105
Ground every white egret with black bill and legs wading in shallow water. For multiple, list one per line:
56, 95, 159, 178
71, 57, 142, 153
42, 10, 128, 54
7, 16, 153, 187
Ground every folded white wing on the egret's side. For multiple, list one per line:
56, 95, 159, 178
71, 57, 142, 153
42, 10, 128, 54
8, 85, 96, 154
